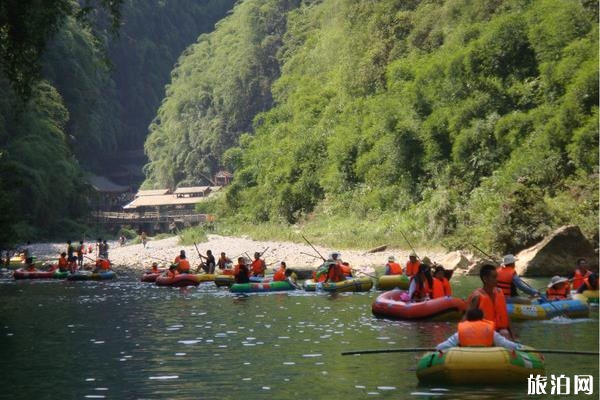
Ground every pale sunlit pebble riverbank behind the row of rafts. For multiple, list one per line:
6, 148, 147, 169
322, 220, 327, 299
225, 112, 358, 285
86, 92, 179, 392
31, 235, 444, 270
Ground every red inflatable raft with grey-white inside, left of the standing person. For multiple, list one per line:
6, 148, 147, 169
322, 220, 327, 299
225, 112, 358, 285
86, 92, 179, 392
371, 289, 467, 321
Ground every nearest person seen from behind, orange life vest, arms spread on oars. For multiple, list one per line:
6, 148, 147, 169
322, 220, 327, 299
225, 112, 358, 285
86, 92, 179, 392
435, 308, 523, 351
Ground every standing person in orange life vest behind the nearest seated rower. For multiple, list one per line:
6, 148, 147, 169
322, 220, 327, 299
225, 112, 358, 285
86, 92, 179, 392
467, 264, 512, 339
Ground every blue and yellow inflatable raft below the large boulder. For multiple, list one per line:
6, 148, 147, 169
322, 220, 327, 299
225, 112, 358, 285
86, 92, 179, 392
506, 299, 590, 321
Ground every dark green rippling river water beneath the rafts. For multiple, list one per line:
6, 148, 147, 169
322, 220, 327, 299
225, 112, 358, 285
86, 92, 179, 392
0, 274, 599, 400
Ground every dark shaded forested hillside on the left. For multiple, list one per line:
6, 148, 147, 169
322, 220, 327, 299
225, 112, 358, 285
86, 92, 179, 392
0, 0, 234, 244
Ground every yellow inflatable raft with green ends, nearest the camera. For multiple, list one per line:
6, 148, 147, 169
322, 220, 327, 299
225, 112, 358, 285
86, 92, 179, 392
417, 347, 545, 385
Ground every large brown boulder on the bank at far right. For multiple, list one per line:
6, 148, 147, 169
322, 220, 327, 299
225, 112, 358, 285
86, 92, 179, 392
515, 225, 598, 276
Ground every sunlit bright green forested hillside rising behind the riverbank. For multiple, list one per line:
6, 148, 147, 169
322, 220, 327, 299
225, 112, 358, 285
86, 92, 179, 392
146, 0, 598, 251
